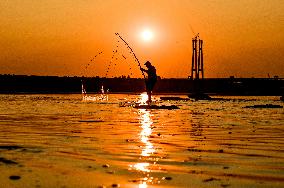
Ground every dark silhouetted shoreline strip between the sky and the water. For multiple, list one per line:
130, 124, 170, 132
0, 75, 284, 96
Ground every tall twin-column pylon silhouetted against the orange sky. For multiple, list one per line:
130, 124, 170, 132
190, 33, 204, 80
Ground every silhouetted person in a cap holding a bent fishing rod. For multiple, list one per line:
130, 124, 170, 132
141, 61, 157, 104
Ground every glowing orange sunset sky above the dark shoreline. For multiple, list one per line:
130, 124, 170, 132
0, 0, 284, 78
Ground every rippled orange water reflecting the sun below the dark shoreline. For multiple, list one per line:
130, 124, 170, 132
0, 94, 284, 188
